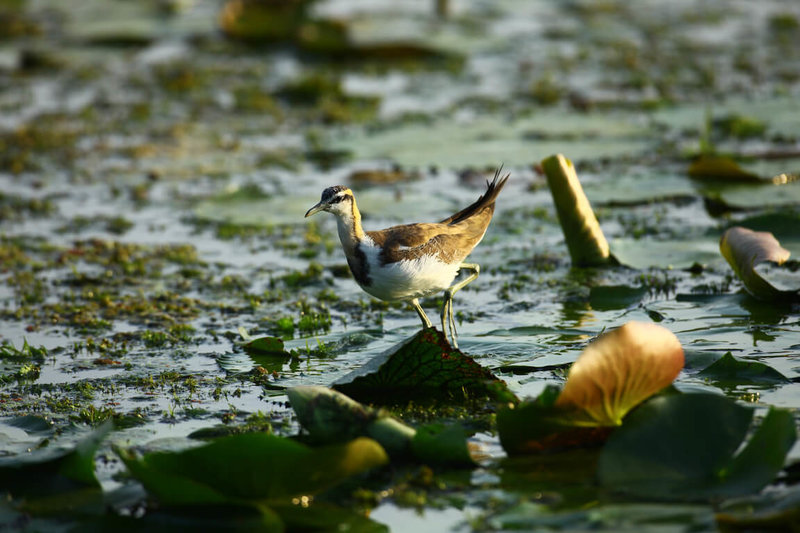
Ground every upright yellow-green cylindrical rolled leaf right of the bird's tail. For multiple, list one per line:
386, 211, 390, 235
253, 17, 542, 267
542, 154, 616, 266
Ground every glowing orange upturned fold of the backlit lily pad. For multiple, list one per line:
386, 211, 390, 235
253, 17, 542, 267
555, 322, 684, 426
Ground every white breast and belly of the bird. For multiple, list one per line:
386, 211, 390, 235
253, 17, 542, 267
361, 238, 459, 301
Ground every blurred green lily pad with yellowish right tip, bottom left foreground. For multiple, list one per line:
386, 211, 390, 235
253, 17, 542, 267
118, 433, 387, 506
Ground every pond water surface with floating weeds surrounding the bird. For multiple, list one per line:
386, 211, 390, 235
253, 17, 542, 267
0, 0, 800, 531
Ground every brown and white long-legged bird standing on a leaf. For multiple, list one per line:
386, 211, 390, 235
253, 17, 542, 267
305, 167, 510, 349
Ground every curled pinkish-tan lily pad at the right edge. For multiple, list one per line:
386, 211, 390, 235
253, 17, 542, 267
719, 226, 800, 301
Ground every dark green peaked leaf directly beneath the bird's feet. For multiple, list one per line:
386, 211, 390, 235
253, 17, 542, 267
333, 328, 513, 403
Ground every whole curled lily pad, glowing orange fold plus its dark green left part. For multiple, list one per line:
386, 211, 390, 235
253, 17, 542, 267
497, 322, 684, 455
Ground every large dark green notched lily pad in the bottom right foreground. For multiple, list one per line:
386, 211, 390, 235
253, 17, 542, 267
598, 393, 796, 500
